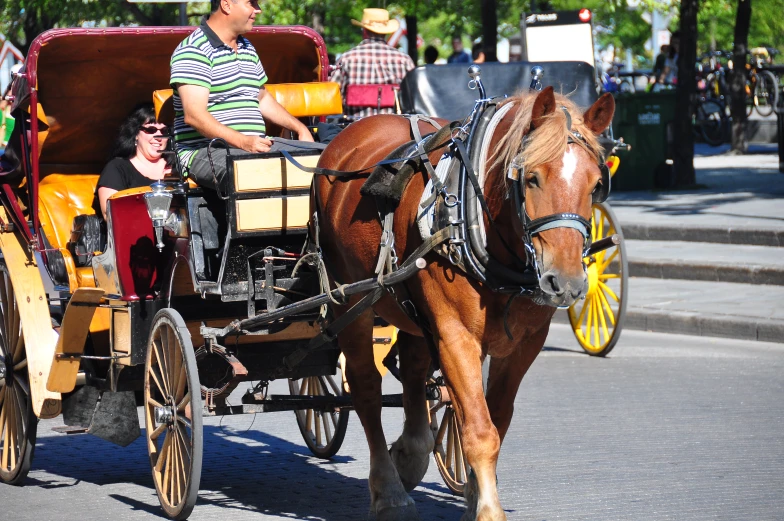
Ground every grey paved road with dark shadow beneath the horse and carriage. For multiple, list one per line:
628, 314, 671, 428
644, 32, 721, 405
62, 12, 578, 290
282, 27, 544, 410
0, 326, 784, 521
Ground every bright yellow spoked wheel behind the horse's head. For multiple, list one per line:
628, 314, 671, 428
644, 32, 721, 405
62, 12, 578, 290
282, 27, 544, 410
569, 203, 629, 356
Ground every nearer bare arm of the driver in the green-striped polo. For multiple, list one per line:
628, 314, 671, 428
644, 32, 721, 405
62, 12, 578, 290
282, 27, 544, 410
176, 84, 274, 152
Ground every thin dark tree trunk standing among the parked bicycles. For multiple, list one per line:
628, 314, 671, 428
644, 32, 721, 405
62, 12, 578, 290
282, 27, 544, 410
730, 0, 751, 154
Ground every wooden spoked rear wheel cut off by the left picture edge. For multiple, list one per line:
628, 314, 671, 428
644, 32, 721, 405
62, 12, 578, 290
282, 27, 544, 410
0, 261, 38, 485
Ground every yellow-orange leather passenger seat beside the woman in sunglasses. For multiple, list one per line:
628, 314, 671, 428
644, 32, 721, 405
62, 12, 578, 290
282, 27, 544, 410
38, 174, 99, 292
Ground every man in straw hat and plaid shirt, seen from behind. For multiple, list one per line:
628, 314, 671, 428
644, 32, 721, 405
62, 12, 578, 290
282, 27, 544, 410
330, 9, 415, 117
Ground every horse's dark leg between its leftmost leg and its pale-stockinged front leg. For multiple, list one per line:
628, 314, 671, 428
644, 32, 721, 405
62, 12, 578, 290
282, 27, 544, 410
389, 331, 435, 491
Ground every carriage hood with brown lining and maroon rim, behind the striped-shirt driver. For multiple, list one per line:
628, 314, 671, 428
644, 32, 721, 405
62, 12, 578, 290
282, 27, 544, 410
24, 26, 327, 170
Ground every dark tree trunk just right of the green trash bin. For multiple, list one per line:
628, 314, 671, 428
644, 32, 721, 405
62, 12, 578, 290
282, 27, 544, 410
673, 0, 700, 186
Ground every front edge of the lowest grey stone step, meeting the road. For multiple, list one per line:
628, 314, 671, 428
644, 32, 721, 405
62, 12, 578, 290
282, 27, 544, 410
553, 308, 784, 343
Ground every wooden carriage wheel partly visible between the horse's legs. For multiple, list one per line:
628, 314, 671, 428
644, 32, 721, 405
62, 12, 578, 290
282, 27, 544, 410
430, 400, 471, 497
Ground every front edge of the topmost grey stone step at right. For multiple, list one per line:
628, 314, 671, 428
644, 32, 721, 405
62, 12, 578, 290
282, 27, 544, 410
623, 223, 784, 246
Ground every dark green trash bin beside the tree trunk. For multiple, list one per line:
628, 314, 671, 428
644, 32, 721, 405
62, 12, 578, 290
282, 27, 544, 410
612, 90, 675, 190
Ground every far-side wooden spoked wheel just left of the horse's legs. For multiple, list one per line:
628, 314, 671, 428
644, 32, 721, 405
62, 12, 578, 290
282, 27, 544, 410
289, 362, 349, 459
